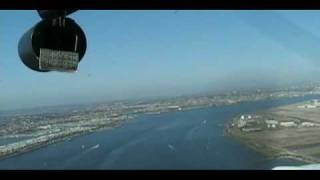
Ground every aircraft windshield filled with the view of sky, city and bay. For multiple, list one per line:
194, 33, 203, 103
0, 10, 320, 169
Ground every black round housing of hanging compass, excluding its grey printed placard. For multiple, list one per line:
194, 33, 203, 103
18, 18, 87, 72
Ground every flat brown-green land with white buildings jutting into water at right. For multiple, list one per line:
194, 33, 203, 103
224, 101, 320, 163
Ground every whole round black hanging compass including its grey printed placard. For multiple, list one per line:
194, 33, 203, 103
18, 18, 87, 72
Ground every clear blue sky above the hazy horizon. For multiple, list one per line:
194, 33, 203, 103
0, 10, 320, 110
